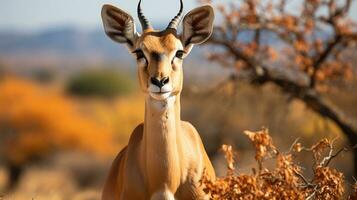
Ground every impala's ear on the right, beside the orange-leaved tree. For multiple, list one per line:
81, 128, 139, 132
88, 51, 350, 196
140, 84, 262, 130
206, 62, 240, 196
181, 5, 214, 48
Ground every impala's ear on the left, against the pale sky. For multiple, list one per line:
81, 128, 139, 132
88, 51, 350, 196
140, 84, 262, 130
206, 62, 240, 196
102, 5, 138, 49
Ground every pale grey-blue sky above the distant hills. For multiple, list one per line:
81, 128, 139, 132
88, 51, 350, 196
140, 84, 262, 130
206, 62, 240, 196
0, 0, 357, 31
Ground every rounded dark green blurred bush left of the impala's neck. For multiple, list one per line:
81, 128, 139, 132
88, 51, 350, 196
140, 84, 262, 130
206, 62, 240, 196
66, 70, 133, 98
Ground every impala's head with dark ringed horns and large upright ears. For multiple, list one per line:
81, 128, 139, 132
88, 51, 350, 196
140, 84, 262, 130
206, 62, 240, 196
102, 0, 214, 100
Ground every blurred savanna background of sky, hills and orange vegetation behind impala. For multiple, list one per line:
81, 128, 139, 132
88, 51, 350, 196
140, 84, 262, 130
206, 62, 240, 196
0, 0, 357, 199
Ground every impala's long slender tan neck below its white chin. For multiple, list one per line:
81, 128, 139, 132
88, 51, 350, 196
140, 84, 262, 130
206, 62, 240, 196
142, 95, 181, 192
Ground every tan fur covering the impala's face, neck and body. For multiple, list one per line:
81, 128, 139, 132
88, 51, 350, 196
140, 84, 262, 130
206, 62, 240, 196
102, 4, 215, 200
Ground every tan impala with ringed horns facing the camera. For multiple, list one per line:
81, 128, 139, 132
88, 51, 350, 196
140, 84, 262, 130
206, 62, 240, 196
102, 0, 215, 200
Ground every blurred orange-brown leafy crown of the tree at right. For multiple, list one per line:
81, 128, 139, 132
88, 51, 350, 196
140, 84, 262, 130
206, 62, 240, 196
202, 0, 357, 88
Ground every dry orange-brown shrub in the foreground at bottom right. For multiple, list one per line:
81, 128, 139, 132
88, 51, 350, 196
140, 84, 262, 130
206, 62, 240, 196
201, 129, 357, 200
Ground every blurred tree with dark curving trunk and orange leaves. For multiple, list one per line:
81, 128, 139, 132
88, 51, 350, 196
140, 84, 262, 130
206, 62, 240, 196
205, 0, 357, 174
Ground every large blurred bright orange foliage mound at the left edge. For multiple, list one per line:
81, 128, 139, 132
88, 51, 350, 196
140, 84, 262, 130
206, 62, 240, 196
0, 77, 114, 165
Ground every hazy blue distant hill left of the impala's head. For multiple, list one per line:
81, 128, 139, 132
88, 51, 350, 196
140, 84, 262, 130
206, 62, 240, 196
0, 27, 125, 59
